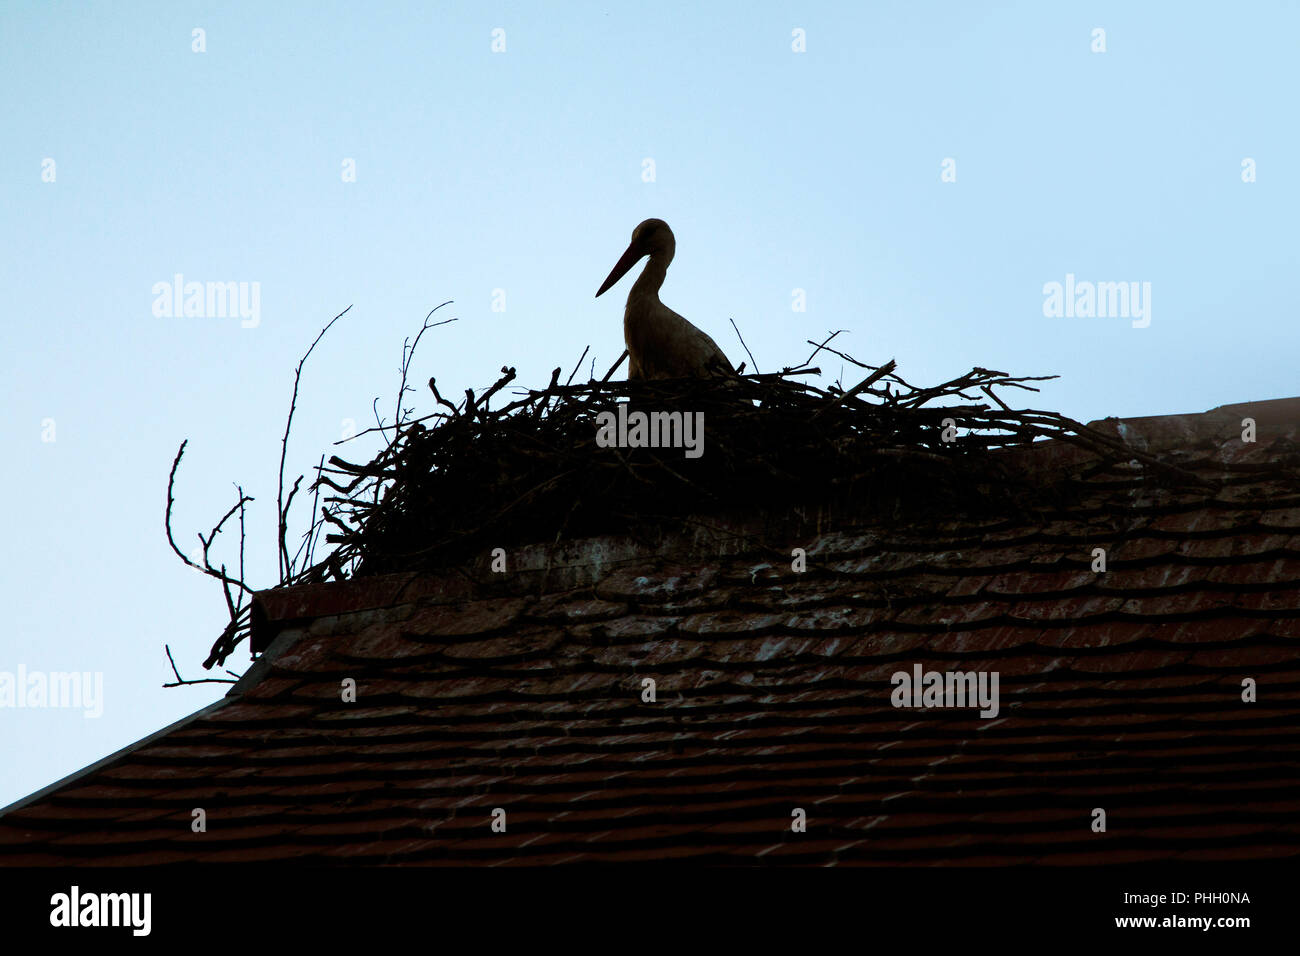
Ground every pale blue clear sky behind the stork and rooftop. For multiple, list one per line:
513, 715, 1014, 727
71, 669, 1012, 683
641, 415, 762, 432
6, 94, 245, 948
0, 0, 1300, 806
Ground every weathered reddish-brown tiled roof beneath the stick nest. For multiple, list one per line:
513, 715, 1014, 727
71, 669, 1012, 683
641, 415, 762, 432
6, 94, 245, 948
0, 399, 1300, 865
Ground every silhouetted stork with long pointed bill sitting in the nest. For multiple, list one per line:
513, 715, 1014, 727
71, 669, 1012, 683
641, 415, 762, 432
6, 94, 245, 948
595, 219, 736, 380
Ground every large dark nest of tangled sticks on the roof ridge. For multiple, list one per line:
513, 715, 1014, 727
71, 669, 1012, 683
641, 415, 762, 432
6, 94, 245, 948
316, 347, 1199, 579
